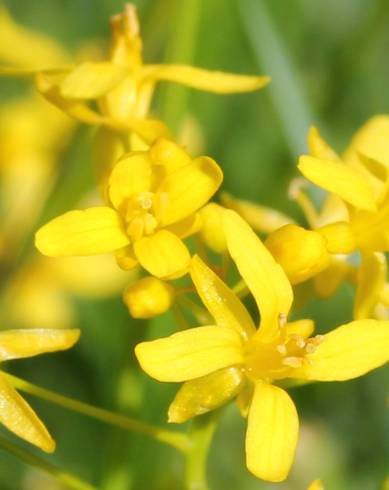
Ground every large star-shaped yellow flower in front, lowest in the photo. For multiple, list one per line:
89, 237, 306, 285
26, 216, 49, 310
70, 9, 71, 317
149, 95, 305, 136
135, 211, 389, 482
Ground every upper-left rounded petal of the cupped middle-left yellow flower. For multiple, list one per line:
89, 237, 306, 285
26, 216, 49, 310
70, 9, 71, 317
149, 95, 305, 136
108, 152, 151, 209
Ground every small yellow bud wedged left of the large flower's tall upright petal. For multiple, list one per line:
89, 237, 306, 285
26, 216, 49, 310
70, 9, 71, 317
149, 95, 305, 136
200, 203, 227, 253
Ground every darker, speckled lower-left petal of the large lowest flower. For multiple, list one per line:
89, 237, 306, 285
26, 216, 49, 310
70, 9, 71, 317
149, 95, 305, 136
168, 367, 244, 424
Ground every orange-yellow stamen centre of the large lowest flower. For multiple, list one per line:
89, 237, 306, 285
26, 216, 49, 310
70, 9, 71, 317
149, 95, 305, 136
245, 326, 323, 381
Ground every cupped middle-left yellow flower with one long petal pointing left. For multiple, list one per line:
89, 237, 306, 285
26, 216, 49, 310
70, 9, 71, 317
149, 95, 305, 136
36, 139, 223, 279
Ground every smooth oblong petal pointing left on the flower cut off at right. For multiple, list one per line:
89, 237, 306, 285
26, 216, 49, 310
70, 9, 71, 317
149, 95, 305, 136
298, 156, 376, 211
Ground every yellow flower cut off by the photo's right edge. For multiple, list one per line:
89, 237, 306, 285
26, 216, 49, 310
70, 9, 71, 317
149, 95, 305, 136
298, 116, 389, 253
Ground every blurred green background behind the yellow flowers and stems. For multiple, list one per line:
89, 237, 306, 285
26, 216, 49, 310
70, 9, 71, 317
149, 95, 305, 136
0, 0, 389, 490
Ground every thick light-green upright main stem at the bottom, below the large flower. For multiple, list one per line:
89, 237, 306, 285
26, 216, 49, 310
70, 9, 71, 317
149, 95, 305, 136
185, 411, 219, 490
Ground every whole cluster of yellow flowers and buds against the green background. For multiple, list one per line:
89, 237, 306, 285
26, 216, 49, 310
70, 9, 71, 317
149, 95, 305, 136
0, 5, 389, 488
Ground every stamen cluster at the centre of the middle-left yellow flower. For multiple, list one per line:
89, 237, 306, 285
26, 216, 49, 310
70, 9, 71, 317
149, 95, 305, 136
124, 192, 167, 241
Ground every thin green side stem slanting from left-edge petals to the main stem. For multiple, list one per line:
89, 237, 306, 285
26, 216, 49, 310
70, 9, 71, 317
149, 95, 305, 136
4, 373, 190, 452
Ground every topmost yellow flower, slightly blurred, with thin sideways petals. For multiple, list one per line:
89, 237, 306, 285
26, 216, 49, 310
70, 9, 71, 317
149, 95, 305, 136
0, 4, 269, 143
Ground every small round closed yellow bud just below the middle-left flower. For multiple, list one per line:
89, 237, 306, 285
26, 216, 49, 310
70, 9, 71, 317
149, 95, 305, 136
123, 277, 174, 318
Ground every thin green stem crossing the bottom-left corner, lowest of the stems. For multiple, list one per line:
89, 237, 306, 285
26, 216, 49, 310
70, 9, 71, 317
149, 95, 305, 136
0, 436, 96, 490
